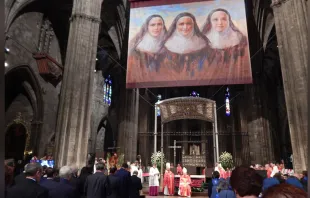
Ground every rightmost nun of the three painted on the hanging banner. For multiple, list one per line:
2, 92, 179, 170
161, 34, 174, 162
202, 8, 248, 64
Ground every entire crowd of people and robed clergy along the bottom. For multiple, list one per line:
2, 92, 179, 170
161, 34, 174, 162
5, 159, 308, 198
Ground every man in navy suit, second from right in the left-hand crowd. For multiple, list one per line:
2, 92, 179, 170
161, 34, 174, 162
115, 163, 131, 198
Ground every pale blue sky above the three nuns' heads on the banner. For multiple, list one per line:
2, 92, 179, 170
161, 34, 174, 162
129, 0, 247, 40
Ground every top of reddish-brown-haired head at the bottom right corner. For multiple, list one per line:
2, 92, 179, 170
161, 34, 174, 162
263, 184, 307, 198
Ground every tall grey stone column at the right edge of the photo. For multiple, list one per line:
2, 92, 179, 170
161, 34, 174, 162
271, 0, 309, 171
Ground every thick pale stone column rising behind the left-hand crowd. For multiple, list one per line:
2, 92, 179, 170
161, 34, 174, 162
56, 0, 102, 167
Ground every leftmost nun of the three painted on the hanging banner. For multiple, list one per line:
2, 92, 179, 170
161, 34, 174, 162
127, 15, 167, 83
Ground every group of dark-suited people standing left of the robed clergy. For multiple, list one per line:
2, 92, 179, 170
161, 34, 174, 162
5, 162, 142, 198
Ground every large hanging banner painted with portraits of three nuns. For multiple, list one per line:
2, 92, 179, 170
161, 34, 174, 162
126, 0, 252, 88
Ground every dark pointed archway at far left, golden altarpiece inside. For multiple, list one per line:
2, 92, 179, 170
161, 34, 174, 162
5, 65, 44, 160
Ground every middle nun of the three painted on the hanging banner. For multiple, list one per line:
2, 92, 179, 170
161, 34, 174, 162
163, 12, 210, 80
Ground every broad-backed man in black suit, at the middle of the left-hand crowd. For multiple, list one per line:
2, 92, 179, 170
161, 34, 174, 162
84, 162, 111, 198
